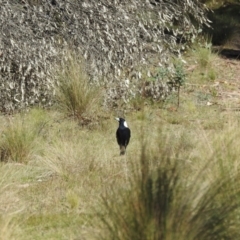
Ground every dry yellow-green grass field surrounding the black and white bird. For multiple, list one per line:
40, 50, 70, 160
0, 48, 240, 240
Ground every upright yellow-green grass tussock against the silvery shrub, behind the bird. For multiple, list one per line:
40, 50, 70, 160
57, 56, 100, 119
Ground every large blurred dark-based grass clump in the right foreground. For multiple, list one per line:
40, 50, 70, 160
98, 134, 240, 240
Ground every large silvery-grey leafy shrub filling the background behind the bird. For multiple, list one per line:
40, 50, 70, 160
0, 0, 208, 112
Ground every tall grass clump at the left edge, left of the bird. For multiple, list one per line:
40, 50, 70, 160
0, 109, 46, 163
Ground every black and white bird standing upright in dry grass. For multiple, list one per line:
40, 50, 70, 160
116, 118, 131, 155
